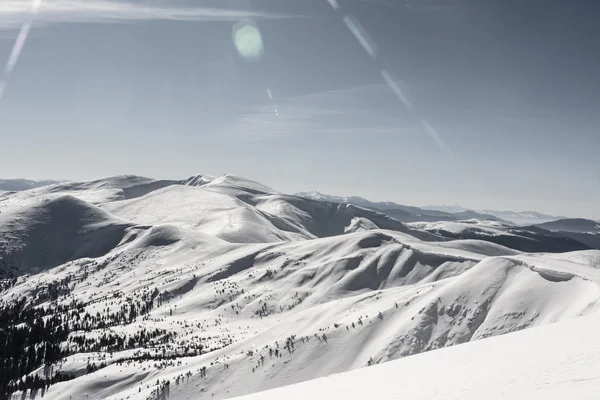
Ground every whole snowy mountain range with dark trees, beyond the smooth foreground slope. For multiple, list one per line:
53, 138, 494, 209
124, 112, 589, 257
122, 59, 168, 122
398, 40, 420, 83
0, 174, 600, 400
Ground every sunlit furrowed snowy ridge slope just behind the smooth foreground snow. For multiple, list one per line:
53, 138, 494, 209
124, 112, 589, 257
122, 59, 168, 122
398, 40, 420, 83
15, 241, 600, 400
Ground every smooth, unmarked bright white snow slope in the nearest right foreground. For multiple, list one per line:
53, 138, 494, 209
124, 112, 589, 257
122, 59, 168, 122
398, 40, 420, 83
240, 316, 600, 400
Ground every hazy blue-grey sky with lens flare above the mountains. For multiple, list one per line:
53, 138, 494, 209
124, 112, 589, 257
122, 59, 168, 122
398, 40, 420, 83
0, 0, 600, 219
